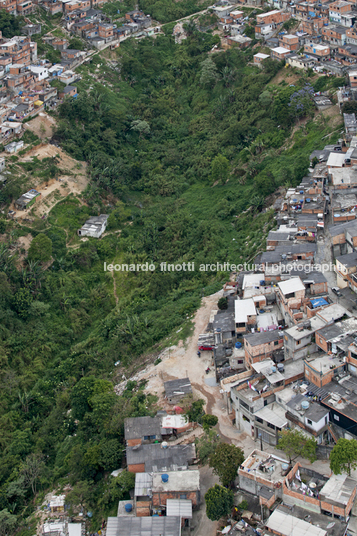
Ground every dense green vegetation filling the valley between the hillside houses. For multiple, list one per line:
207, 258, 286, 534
0, 18, 338, 536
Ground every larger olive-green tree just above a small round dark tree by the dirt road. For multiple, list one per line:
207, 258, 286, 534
209, 443, 244, 486
